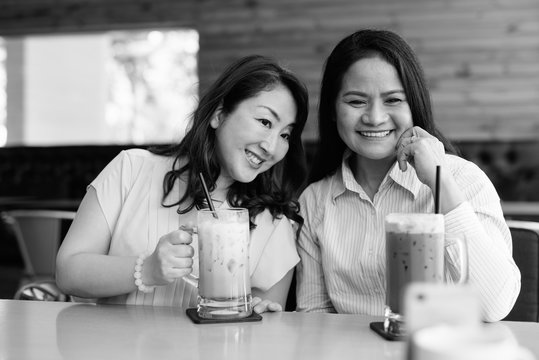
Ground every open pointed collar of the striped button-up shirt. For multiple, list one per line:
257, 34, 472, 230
331, 149, 423, 201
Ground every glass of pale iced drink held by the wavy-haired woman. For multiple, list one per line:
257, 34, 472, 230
197, 208, 252, 319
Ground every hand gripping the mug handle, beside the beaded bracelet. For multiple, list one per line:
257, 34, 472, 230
142, 229, 195, 285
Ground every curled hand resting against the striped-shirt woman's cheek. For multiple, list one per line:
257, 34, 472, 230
397, 126, 450, 190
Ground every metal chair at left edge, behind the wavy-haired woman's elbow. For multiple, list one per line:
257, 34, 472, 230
2, 210, 75, 301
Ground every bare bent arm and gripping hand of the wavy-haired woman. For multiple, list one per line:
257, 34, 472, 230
56, 186, 193, 298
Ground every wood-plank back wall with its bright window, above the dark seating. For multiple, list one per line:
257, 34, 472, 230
0, 0, 539, 145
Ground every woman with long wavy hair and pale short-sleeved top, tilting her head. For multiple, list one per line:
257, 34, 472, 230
57, 55, 308, 312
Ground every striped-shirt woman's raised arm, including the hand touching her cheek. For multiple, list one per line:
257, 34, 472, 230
397, 126, 520, 321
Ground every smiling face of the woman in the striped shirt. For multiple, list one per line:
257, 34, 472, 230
335, 57, 413, 160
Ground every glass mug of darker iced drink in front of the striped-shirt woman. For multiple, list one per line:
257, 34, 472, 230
384, 213, 468, 336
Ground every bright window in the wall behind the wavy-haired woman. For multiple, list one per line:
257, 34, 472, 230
0, 29, 198, 145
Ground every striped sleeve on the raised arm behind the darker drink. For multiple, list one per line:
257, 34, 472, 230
445, 165, 520, 321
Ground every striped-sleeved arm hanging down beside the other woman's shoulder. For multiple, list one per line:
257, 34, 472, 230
297, 187, 336, 312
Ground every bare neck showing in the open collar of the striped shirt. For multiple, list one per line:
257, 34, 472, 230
348, 154, 395, 200
